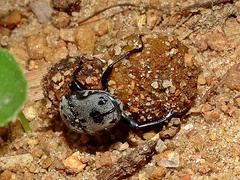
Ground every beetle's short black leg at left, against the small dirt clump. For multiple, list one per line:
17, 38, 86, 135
68, 61, 87, 92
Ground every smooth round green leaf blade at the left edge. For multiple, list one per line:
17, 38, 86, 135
0, 48, 27, 126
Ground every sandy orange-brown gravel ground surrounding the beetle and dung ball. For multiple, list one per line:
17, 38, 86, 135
0, 0, 240, 180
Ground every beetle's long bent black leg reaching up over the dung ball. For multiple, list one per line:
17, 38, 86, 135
102, 35, 143, 91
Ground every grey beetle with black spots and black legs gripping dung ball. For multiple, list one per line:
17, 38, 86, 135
59, 36, 189, 135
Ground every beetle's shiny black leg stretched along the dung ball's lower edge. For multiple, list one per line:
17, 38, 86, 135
122, 108, 190, 129
